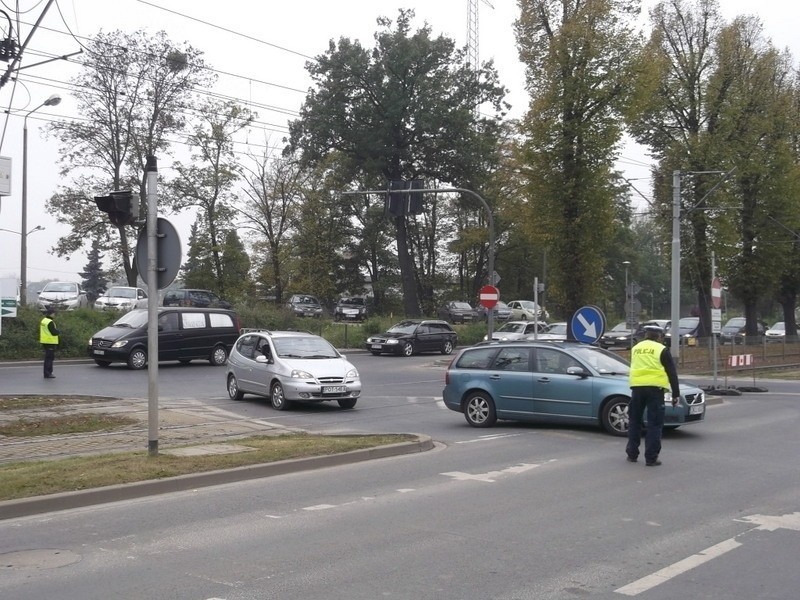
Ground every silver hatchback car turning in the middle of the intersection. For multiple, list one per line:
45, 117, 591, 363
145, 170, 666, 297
226, 329, 361, 410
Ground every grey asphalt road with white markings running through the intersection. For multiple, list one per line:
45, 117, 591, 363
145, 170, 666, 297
0, 354, 800, 600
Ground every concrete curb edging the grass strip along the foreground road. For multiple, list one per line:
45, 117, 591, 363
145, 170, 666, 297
0, 435, 435, 520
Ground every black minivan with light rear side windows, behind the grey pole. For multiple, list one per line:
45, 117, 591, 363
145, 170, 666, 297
88, 306, 239, 369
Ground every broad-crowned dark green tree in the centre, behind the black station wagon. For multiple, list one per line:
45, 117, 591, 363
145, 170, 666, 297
290, 10, 505, 315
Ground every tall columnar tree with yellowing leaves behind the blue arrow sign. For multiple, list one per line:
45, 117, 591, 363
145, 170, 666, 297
515, 0, 642, 326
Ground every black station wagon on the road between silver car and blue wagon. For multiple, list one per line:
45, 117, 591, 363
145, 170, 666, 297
365, 319, 458, 356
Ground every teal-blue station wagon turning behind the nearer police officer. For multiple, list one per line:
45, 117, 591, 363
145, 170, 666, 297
443, 341, 706, 436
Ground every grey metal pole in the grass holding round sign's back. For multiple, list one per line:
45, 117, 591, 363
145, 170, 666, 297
145, 156, 158, 456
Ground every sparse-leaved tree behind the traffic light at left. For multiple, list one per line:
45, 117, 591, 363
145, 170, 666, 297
47, 31, 212, 286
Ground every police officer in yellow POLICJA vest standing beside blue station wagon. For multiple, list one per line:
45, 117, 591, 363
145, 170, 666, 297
625, 325, 681, 467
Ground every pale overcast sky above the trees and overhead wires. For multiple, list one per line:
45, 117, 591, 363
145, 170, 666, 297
0, 0, 800, 282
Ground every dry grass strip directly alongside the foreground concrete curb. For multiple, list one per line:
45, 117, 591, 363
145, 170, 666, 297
0, 434, 416, 500
